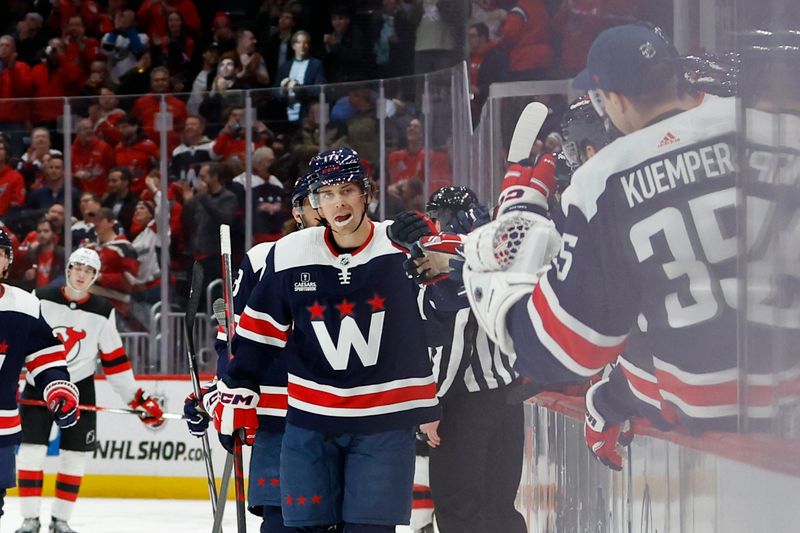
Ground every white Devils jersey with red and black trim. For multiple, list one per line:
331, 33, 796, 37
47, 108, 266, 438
33, 287, 137, 401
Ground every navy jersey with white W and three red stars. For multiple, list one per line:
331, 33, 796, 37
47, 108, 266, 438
227, 222, 439, 433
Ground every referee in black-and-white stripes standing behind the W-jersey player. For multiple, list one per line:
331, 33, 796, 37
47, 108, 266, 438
422, 187, 527, 533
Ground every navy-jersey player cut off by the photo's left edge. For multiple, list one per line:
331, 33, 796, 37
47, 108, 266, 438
0, 231, 80, 528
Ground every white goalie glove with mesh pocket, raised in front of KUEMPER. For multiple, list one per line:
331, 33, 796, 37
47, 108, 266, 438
463, 210, 561, 353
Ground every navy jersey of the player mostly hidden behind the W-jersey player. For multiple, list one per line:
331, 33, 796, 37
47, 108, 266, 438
215, 242, 291, 431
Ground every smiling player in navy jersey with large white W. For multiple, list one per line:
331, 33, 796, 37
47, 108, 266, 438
214, 148, 438, 533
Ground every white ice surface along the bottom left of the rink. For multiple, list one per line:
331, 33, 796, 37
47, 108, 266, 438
0, 498, 411, 533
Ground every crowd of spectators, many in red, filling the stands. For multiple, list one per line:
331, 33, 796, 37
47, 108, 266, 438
0, 0, 656, 328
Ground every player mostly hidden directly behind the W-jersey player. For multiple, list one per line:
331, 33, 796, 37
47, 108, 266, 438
184, 172, 320, 533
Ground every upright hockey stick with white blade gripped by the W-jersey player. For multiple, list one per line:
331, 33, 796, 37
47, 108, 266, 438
219, 224, 247, 533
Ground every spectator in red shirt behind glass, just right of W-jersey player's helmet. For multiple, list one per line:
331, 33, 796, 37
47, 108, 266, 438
387, 118, 452, 194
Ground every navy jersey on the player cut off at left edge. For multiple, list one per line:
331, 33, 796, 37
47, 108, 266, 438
0, 283, 69, 447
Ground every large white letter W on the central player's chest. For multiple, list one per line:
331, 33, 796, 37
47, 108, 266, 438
311, 311, 386, 370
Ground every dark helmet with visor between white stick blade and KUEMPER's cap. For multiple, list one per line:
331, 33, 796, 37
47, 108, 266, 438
561, 96, 611, 171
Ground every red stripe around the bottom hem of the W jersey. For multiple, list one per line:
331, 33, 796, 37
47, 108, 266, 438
288, 383, 436, 409
